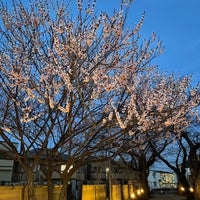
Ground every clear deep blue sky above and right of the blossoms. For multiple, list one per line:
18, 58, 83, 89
97, 0, 200, 83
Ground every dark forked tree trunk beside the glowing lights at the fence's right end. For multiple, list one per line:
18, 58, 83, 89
117, 133, 170, 200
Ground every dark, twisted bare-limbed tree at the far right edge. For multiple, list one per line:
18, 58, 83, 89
155, 130, 200, 200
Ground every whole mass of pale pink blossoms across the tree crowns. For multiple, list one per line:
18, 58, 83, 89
0, 0, 199, 144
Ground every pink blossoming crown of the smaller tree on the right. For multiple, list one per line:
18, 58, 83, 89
114, 71, 200, 135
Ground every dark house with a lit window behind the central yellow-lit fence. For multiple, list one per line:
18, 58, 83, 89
28, 160, 139, 199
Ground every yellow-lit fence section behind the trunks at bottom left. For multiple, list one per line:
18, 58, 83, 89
0, 186, 61, 200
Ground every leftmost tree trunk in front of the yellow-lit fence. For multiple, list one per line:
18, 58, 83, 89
26, 170, 36, 200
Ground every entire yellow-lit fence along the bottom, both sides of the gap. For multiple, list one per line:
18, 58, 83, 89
0, 185, 138, 200
